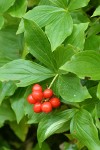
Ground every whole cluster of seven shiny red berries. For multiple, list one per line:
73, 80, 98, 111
27, 84, 60, 113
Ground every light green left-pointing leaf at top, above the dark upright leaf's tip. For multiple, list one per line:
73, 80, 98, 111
24, 5, 65, 27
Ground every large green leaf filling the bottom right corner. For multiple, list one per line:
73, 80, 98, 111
70, 109, 100, 150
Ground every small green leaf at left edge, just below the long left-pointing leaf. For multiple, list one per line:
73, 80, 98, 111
0, 81, 17, 105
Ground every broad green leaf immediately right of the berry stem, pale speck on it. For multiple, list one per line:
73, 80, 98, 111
58, 74, 91, 103
